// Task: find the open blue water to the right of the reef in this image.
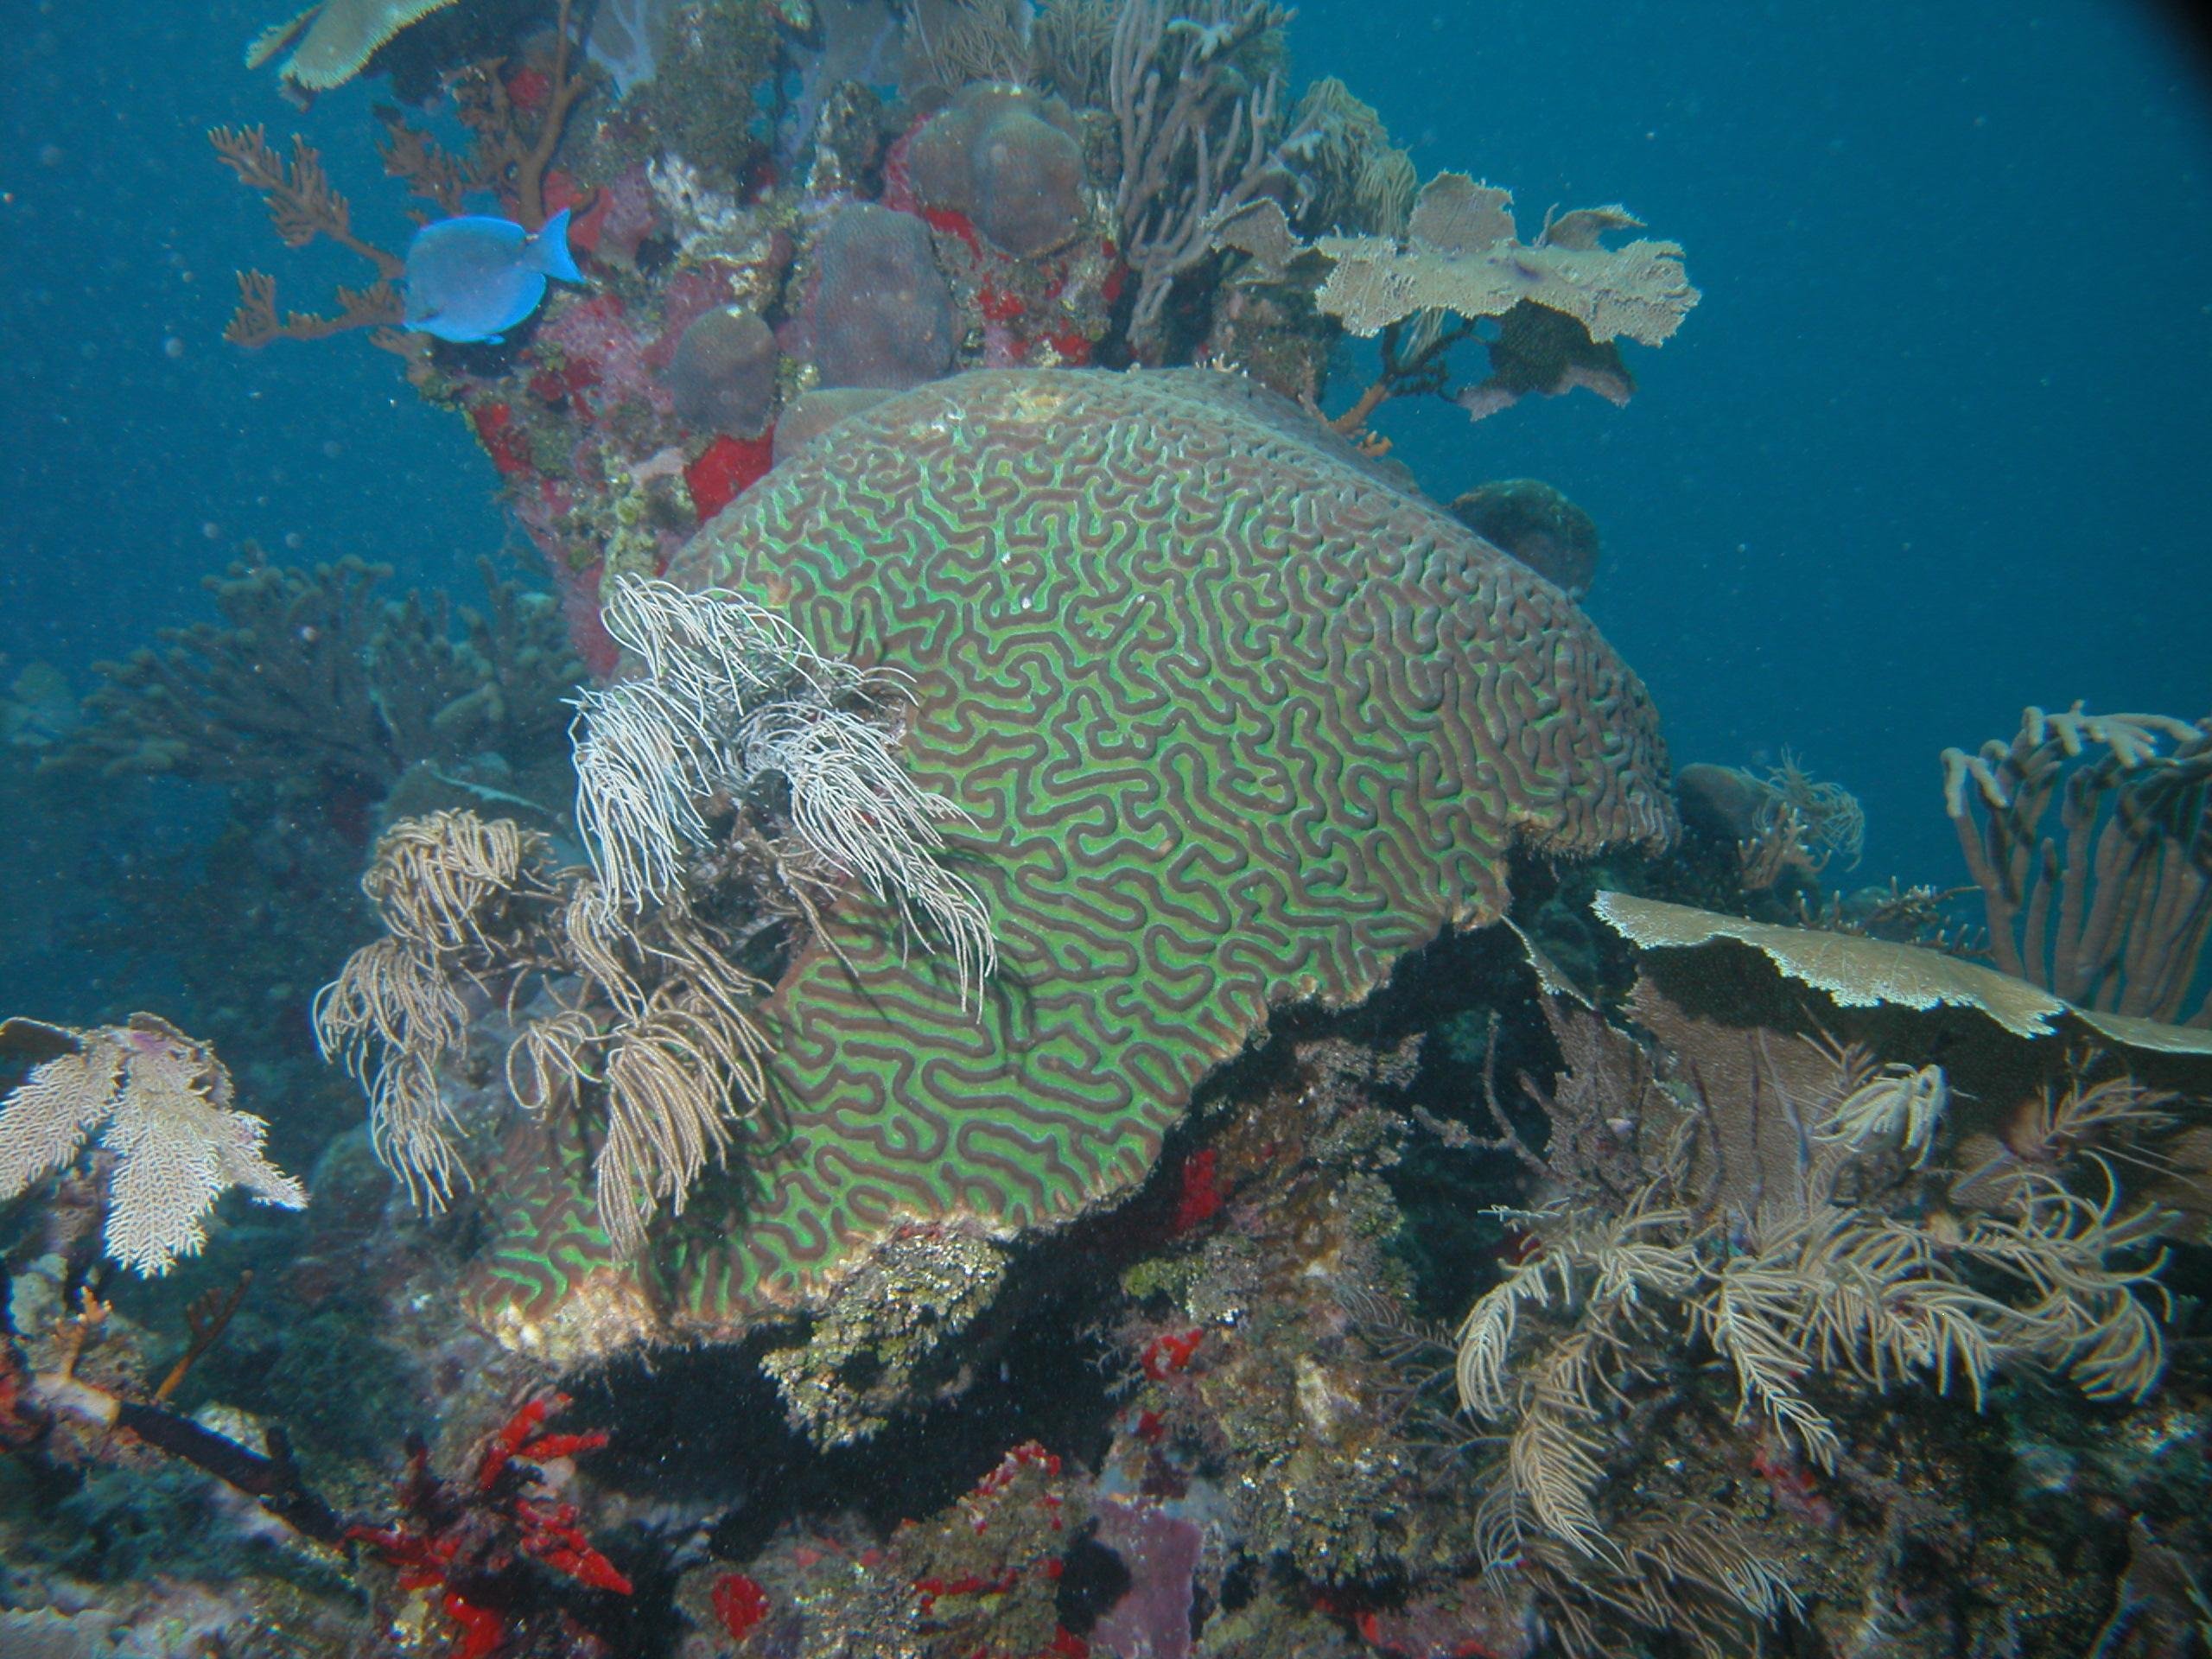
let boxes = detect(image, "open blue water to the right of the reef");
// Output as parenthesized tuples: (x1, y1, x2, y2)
(1299, 0, 2212, 882)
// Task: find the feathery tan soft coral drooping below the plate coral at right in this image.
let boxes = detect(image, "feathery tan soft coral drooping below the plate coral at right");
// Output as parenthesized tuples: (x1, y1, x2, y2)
(1458, 982, 2170, 1617)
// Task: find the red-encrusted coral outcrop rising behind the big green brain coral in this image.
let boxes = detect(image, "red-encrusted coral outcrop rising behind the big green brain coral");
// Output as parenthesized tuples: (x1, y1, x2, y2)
(217, 0, 1690, 675)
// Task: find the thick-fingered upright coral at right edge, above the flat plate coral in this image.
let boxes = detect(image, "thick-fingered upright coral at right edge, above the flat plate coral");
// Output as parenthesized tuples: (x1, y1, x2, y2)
(1942, 703, 2212, 1024)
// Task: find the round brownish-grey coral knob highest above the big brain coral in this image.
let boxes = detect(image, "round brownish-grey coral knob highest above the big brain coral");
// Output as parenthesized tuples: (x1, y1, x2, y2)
(907, 84, 1084, 259)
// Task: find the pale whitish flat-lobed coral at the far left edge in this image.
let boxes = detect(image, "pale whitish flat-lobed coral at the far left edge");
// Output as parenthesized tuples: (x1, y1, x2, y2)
(0, 1013, 308, 1274)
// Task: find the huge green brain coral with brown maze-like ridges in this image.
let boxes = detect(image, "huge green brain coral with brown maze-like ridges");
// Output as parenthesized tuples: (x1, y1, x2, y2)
(471, 370, 1672, 1336)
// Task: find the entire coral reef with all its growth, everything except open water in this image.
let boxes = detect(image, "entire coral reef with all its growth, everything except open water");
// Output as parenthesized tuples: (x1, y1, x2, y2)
(0, 0, 2212, 1659)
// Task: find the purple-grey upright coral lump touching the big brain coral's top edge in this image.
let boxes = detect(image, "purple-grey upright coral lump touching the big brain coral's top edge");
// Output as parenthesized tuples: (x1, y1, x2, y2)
(814, 201, 953, 391)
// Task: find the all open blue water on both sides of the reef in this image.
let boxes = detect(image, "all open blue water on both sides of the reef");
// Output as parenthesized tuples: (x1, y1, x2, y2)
(0, 0, 2212, 902)
